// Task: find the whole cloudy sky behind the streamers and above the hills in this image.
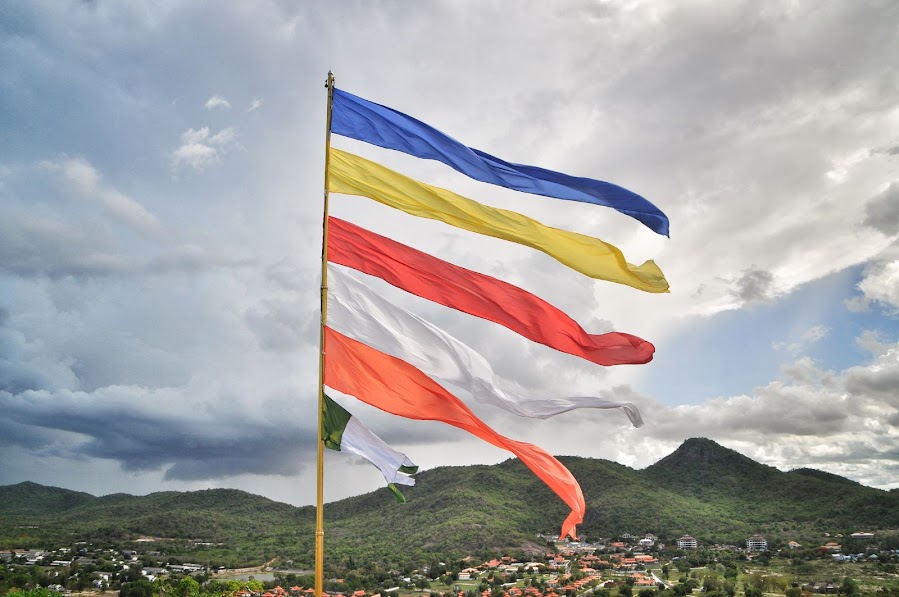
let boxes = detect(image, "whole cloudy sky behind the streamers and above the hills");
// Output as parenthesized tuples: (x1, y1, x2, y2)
(0, 0, 899, 505)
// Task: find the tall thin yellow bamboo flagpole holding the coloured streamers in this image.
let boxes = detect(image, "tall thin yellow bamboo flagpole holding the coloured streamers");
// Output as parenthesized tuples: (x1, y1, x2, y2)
(315, 71, 334, 597)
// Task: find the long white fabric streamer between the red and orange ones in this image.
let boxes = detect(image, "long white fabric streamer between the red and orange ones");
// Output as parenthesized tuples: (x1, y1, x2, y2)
(327, 265, 643, 427)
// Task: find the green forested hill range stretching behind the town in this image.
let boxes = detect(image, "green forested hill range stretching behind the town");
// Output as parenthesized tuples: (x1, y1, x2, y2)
(0, 439, 899, 563)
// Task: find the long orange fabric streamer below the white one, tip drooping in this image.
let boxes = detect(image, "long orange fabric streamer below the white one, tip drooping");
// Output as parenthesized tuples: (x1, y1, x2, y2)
(324, 326, 586, 537)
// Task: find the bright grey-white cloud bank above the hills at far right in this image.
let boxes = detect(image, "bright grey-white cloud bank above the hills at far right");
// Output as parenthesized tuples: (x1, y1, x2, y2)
(632, 344, 899, 486)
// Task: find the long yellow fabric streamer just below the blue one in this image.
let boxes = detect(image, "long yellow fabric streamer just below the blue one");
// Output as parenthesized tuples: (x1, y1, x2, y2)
(328, 147, 668, 292)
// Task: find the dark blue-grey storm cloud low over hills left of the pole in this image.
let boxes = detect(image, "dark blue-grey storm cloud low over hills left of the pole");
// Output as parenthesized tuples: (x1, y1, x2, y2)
(0, 387, 316, 480)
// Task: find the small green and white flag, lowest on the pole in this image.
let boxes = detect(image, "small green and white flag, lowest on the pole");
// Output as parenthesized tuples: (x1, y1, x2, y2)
(322, 394, 418, 502)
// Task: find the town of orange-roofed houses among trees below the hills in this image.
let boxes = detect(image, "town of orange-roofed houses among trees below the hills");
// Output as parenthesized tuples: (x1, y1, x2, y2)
(0, 531, 899, 597)
